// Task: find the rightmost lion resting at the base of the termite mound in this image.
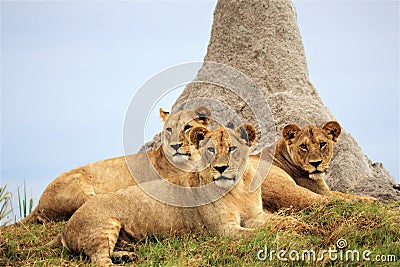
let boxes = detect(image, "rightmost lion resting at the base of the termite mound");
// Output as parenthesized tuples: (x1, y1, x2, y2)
(262, 121, 375, 211)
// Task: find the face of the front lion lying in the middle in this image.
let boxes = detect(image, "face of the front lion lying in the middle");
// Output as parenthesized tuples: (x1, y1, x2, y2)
(190, 124, 256, 188)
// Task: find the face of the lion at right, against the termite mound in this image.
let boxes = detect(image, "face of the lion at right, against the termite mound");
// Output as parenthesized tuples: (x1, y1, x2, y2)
(282, 121, 341, 179)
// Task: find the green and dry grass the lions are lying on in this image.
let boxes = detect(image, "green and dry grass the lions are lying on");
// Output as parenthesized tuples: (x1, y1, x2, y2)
(0, 201, 400, 267)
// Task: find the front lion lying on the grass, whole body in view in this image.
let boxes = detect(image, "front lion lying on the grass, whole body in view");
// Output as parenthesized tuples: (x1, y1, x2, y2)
(51, 124, 298, 266)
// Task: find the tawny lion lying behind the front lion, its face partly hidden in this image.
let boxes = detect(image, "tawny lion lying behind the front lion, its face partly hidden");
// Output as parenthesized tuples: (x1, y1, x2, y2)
(20, 107, 211, 223)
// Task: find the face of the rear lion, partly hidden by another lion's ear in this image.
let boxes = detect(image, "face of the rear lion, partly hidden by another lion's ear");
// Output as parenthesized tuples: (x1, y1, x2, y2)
(160, 107, 211, 164)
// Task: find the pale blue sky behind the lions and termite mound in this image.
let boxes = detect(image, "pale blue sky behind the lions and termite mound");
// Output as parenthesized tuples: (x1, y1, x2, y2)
(0, 1, 399, 215)
